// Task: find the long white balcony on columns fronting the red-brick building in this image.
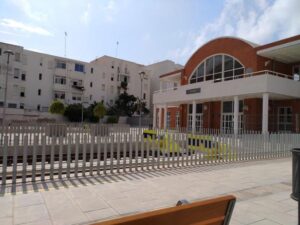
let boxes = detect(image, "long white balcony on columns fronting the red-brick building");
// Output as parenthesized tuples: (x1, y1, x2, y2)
(153, 70, 300, 104)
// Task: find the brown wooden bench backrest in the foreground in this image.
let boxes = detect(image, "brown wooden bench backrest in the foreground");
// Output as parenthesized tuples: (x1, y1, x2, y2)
(94, 195, 236, 225)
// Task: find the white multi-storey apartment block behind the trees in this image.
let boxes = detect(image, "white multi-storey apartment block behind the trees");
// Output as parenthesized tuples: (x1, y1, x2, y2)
(0, 42, 178, 123)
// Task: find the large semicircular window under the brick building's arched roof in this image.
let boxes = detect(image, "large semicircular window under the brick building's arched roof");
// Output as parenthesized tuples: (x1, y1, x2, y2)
(190, 54, 245, 84)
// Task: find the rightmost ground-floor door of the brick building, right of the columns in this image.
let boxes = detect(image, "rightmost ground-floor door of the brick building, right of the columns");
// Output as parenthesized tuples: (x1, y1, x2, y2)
(278, 107, 292, 132)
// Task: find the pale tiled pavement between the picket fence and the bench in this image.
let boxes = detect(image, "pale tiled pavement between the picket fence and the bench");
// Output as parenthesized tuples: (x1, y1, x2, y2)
(0, 159, 297, 225)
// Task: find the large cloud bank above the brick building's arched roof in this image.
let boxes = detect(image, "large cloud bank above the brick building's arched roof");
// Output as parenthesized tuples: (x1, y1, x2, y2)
(169, 0, 300, 62)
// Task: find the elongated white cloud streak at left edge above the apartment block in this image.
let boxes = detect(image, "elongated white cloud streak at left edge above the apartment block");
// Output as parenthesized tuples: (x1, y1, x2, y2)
(0, 18, 52, 36)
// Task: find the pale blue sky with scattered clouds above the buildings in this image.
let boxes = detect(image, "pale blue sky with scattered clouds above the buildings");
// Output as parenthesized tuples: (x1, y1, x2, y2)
(0, 0, 300, 65)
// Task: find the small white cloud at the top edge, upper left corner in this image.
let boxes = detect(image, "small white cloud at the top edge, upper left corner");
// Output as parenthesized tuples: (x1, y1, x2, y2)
(10, 0, 47, 21)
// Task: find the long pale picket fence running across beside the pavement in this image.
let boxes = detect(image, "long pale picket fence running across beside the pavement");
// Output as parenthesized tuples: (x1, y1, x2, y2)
(0, 125, 300, 185)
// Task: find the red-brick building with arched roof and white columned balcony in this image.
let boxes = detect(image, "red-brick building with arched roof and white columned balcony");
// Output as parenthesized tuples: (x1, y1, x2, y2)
(153, 35, 300, 133)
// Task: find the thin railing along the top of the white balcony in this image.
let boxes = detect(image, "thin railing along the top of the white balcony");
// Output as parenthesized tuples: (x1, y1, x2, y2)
(154, 70, 294, 94)
